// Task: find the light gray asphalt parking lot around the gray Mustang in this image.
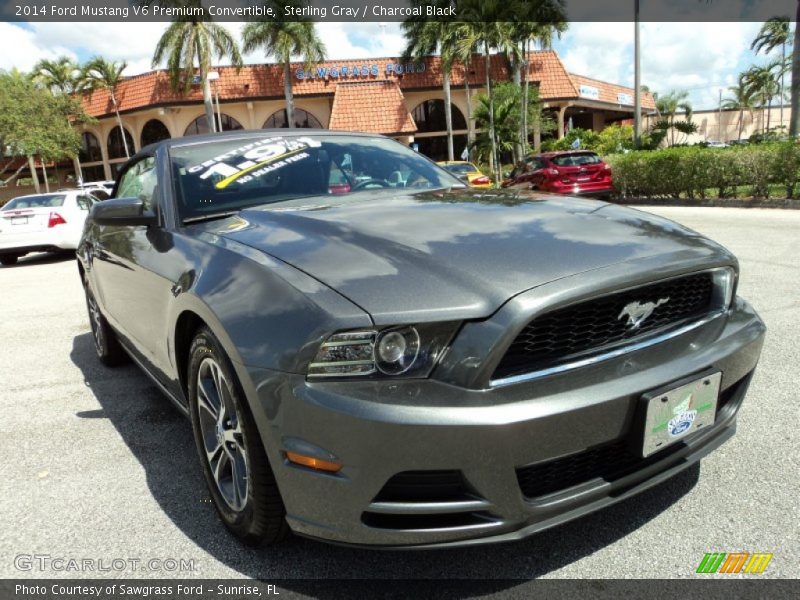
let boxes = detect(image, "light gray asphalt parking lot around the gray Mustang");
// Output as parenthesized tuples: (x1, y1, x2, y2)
(0, 208, 800, 580)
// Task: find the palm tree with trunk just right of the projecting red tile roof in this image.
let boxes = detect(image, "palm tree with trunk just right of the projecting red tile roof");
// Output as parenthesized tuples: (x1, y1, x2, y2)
(401, 0, 460, 160)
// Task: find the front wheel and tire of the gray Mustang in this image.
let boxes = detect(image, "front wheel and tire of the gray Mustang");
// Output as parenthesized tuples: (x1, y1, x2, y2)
(187, 327, 288, 546)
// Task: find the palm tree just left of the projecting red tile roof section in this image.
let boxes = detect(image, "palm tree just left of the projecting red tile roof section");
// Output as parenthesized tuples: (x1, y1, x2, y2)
(242, 0, 325, 127)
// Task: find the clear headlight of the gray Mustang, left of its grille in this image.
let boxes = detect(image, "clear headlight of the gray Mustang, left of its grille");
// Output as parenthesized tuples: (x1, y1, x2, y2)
(308, 323, 459, 379)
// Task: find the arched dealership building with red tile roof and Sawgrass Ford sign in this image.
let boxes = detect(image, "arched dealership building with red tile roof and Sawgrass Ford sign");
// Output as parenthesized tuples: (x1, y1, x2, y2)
(7, 51, 655, 189)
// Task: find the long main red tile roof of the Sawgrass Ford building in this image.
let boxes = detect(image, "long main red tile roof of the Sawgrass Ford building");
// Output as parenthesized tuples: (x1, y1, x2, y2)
(78, 51, 649, 117)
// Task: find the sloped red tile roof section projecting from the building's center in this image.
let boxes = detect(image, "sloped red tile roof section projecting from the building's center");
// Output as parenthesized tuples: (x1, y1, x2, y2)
(329, 80, 417, 134)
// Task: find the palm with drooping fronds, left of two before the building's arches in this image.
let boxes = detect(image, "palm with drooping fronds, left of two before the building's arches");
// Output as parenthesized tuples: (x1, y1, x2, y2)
(146, 0, 242, 132)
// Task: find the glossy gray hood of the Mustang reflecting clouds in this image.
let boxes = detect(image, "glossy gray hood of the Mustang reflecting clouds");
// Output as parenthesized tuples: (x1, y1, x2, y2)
(205, 190, 720, 324)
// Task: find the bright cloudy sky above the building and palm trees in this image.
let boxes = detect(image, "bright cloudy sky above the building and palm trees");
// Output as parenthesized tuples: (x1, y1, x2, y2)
(0, 22, 784, 110)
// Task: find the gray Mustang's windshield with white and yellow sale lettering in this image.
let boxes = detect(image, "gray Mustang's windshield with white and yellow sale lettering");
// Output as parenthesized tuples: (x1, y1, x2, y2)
(170, 133, 463, 220)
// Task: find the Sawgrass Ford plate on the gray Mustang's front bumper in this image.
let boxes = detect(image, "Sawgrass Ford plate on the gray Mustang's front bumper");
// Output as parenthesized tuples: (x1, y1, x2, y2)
(642, 371, 722, 456)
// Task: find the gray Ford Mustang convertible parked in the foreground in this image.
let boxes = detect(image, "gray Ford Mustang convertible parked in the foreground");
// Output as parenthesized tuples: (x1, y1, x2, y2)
(78, 130, 765, 547)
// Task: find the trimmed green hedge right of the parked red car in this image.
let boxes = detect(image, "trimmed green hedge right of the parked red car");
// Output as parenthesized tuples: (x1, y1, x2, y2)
(606, 141, 800, 198)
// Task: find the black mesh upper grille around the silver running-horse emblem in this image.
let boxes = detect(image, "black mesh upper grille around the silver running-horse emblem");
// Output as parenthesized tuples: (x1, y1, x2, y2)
(492, 272, 714, 379)
